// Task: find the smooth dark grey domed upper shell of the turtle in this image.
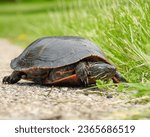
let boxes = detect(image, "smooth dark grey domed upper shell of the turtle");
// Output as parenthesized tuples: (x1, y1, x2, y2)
(11, 36, 109, 71)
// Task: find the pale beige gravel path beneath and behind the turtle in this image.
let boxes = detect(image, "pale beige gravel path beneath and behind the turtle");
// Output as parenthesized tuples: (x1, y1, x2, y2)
(0, 39, 150, 119)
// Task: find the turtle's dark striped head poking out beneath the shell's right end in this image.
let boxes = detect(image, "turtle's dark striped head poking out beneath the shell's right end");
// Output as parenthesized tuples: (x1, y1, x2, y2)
(89, 62, 116, 80)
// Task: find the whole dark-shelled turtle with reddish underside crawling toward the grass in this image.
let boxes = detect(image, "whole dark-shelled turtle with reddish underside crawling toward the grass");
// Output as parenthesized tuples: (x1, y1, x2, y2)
(2, 36, 127, 86)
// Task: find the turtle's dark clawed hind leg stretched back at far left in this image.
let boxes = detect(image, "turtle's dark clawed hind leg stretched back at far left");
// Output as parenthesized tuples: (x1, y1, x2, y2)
(2, 71, 25, 84)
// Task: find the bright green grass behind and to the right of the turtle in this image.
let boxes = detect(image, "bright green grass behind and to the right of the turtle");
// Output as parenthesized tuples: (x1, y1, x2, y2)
(0, 0, 150, 96)
